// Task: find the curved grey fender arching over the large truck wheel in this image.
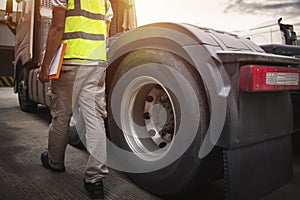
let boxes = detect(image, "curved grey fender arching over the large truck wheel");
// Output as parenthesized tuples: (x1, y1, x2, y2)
(107, 23, 230, 158)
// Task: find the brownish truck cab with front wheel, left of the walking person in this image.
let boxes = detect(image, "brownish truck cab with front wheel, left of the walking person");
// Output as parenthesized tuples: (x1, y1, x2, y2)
(7, 0, 52, 112)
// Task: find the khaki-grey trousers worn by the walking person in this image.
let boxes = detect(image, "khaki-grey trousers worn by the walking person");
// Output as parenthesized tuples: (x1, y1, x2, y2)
(48, 63, 109, 183)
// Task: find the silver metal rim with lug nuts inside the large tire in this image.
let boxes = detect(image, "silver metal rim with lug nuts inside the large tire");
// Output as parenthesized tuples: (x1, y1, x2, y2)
(121, 76, 176, 161)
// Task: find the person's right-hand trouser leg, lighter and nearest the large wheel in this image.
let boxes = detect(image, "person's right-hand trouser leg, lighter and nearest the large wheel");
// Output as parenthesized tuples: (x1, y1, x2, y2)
(73, 66, 109, 183)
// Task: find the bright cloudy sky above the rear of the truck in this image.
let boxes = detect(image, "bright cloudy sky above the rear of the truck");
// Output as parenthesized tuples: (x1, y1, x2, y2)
(0, 0, 300, 34)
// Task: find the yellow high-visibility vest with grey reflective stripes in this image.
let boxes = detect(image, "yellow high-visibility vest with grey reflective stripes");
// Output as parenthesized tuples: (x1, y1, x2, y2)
(63, 0, 106, 61)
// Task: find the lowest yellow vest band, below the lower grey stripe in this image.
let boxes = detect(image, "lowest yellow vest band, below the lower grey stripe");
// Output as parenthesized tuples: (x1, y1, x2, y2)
(63, 39, 106, 60)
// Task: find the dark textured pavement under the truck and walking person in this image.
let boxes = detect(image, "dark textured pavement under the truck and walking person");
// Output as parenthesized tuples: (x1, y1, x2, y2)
(0, 88, 300, 200)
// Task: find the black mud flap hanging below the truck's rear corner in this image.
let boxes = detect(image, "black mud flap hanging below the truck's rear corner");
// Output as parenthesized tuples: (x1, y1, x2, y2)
(223, 135, 293, 200)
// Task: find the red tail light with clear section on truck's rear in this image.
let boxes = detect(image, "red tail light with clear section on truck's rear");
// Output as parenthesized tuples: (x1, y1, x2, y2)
(240, 65, 300, 92)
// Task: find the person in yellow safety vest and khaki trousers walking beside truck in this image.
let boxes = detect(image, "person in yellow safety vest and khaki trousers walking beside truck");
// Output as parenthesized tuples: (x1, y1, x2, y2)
(39, 0, 113, 199)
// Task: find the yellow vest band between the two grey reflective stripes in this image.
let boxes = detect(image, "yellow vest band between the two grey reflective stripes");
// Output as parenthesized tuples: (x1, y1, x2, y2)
(65, 16, 106, 34)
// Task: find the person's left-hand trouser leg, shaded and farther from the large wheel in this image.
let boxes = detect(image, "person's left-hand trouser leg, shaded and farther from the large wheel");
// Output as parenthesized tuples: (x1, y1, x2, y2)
(48, 68, 76, 169)
